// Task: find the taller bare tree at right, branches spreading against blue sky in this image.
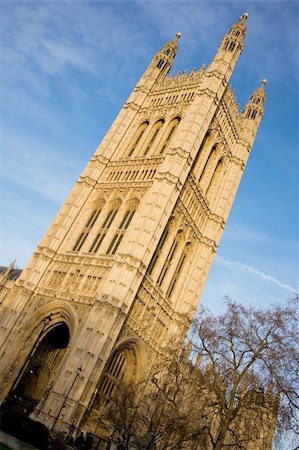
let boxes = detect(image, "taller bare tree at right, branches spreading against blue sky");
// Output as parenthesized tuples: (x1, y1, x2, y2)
(192, 297, 299, 450)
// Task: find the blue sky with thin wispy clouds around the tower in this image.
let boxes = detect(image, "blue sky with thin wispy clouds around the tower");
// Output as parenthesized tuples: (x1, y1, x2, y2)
(0, 0, 299, 311)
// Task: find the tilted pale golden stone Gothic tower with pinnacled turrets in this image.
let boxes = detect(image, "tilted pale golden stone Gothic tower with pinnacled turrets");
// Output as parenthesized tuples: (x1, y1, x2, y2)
(0, 14, 265, 436)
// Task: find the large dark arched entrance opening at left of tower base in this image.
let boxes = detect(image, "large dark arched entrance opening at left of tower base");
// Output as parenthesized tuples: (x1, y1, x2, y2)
(5, 322, 70, 414)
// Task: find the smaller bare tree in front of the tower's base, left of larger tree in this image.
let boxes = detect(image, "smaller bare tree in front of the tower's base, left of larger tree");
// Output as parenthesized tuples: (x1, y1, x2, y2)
(102, 351, 205, 450)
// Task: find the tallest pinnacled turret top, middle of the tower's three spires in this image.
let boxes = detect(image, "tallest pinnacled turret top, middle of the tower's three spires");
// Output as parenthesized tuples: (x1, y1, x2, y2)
(208, 13, 248, 82)
